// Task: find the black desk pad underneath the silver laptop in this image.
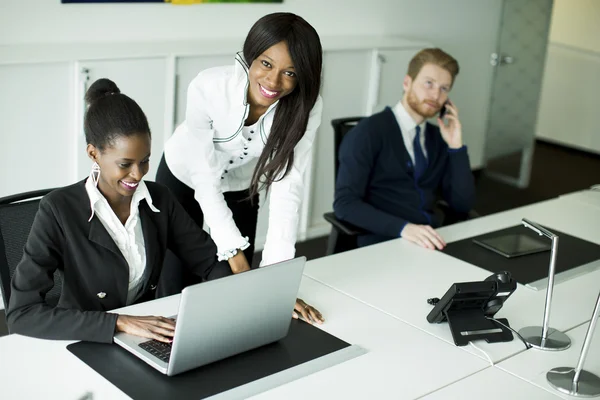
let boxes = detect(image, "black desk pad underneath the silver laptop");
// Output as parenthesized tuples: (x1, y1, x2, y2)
(67, 320, 350, 400)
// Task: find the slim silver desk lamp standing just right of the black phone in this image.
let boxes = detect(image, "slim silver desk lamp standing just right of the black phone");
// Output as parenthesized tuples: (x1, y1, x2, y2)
(519, 218, 571, 351)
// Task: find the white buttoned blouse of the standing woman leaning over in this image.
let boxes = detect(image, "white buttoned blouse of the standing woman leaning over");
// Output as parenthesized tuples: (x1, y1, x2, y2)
(165, 53, 323, 265)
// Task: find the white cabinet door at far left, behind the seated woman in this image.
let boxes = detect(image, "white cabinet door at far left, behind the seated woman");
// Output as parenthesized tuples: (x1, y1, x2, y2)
(0, 62, 75, 197)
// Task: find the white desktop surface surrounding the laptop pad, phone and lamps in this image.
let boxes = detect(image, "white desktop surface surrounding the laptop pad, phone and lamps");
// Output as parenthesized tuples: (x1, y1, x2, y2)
(0, 198, 600, 400)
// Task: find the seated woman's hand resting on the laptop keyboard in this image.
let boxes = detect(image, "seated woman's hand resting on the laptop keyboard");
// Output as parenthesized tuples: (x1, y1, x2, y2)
(116, 315, 175, 343)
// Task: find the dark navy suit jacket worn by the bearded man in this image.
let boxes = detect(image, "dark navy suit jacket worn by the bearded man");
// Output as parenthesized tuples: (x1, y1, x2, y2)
(333, 107, 475, 245)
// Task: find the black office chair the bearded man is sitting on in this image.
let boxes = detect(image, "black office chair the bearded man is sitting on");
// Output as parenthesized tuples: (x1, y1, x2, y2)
(323, 117, 479, 255)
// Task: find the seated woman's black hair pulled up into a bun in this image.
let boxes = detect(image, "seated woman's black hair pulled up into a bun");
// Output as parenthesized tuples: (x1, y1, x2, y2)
(83, 78, 150, 151)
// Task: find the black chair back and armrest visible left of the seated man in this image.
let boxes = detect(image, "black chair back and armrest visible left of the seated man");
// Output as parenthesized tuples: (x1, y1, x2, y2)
(323, 117, 365, 255)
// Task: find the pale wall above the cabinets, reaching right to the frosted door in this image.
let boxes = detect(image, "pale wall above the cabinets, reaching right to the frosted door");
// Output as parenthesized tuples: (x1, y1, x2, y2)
(0, 0, 502, 167)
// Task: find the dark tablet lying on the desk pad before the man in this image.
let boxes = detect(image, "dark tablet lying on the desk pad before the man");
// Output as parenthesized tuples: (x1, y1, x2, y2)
(473, 233, 550, 258)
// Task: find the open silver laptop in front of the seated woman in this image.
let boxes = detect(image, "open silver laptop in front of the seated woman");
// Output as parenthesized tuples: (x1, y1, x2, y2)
(114, 257, 306, 376)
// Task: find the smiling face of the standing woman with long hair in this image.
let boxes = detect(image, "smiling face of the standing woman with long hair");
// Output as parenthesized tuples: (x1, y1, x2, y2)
(248, 42, 298, 108)
